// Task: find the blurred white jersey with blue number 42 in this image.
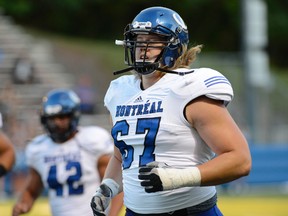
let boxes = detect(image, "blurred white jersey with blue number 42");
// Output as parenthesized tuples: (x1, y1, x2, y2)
(26, 126, 114, 216)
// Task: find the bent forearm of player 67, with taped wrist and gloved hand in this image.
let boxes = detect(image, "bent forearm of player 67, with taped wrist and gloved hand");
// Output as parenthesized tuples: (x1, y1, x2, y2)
(138, 148, 251, 193)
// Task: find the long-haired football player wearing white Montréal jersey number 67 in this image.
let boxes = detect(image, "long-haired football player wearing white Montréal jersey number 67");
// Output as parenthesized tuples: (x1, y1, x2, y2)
(91, 7, 251, 216)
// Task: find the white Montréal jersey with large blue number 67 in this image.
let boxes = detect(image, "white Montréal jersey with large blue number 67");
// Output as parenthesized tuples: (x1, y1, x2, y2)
(104, 68, 233, 214)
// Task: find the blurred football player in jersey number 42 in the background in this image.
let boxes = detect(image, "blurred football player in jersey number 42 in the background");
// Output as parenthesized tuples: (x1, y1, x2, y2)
(13, 89, 122, 216)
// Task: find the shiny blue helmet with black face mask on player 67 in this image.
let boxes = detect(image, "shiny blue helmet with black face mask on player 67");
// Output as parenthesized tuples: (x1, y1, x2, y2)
(117, 7, 189, 75)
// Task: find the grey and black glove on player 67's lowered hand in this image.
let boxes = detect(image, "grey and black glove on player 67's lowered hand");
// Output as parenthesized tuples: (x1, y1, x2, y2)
(90, 184, 112, 216)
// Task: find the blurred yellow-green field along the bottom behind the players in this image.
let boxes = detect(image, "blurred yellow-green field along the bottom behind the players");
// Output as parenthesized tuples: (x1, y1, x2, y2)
(0, 195, 288, 216)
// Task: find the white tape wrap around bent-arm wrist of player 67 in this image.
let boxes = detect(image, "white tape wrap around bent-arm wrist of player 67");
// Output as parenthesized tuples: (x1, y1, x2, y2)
(157, 167, 201, 190)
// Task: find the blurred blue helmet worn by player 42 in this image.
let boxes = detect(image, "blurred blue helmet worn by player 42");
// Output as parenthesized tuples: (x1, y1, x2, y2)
(40, 89, 80, 143)
